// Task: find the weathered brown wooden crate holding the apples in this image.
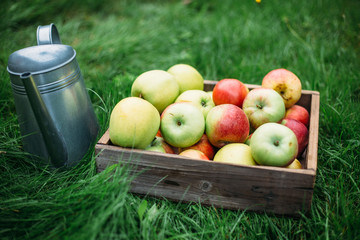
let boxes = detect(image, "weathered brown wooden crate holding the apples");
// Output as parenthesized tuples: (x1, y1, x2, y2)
(95, 81, 320, 216)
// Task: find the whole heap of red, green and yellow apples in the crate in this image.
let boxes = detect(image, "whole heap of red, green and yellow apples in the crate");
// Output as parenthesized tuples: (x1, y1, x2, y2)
(109, 64, 309, 168)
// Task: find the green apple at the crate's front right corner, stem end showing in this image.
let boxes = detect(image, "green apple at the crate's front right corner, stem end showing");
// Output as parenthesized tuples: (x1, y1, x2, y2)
(250, 123, 298, 167)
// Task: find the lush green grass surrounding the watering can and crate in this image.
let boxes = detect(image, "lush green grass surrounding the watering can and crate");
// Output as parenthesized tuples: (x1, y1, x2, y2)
(0, 0, 360, 239)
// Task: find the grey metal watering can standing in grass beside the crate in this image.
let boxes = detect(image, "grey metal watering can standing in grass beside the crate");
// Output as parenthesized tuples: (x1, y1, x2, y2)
(7, 24, 99, 167)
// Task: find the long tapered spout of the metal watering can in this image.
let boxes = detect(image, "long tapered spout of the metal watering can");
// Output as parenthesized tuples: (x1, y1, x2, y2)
(20, 72, 68, 167)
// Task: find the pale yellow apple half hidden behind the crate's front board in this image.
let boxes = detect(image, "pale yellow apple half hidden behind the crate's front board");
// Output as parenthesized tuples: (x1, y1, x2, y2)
(214, 143, 257, 166)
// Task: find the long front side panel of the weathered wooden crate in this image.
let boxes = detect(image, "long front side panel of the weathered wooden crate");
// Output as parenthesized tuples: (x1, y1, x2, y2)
(97, 146, 314, 215)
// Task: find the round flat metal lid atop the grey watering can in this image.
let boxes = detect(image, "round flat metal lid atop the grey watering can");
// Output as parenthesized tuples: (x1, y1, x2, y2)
(7, 44, 76, 75)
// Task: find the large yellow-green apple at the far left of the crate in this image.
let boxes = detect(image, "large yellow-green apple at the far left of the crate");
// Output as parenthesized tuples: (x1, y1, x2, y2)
(109, 97, 160, 149)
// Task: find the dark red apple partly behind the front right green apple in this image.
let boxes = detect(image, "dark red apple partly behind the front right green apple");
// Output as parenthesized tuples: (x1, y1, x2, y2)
(281, 118, 309, 157)
